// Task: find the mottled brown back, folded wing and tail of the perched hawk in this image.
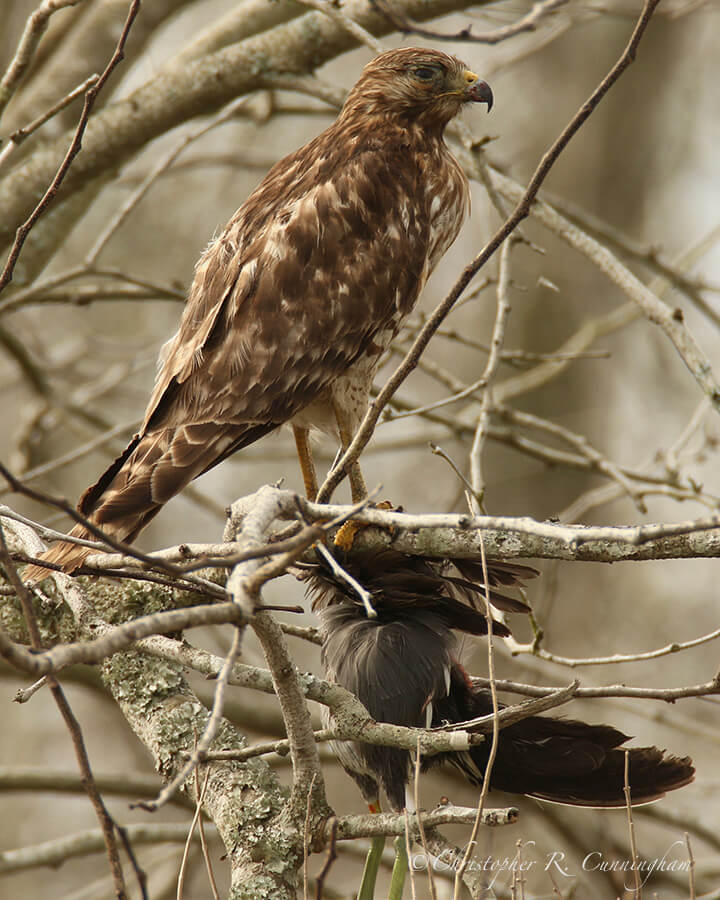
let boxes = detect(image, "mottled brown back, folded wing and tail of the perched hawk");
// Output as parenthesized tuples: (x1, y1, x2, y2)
(28, 129, 448, 576)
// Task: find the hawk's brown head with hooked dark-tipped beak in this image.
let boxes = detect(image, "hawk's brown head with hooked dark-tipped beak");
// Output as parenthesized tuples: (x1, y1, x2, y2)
(345, 47, 493, 129)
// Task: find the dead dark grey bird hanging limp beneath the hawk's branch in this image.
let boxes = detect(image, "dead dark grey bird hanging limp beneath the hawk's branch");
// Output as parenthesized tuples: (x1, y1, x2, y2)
(306, 550, 694, 896)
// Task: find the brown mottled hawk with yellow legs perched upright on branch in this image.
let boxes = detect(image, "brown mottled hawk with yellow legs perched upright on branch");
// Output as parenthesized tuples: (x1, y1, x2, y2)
(27, 48, 493, 579)
